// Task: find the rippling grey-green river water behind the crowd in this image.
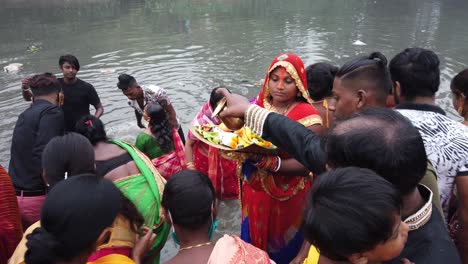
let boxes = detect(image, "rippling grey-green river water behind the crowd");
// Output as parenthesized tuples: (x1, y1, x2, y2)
(0, 0, 468, 259)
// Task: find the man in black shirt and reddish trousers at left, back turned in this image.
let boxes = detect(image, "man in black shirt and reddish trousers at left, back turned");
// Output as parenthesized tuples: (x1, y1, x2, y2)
(8, 73, 64, 229)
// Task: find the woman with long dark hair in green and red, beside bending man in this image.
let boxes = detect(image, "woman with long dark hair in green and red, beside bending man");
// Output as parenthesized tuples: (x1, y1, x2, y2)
(135, 102, 186, 179)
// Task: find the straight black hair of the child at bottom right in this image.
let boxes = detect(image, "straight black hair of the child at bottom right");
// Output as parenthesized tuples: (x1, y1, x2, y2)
(303, 167, 401, 261)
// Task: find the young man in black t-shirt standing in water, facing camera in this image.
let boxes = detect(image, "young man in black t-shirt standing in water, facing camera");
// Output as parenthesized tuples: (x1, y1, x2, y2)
(58, 54, 104, 131)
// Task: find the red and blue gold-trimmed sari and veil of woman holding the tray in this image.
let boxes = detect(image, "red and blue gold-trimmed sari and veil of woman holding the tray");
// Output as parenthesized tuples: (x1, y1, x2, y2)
(241, 54, 322, 263)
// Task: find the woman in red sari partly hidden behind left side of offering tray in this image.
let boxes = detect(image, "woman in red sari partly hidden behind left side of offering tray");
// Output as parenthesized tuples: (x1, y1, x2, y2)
(185, 87, 239, 200)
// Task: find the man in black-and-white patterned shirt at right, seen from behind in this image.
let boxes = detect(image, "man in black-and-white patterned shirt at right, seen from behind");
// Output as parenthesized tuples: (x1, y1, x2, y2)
(389, 48, 468, 262)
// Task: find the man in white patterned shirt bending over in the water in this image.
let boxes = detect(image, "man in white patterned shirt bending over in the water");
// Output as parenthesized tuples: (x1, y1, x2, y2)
(117, 73, 185, 144)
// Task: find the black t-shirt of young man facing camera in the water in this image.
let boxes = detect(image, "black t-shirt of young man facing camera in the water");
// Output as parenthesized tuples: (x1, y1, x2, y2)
(58, 78, 101, 131)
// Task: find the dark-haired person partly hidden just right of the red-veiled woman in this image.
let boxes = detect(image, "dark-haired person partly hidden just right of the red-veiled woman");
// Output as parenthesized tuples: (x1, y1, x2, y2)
(306, 63, 338, 130)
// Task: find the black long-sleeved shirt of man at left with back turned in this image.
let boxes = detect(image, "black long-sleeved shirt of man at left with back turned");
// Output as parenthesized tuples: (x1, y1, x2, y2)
(8, 100, 64, 191)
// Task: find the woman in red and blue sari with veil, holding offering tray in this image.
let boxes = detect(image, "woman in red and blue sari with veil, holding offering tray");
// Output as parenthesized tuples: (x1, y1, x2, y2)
(241, 53, 322, 263)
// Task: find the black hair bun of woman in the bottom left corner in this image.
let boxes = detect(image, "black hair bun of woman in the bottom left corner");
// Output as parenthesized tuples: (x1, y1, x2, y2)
(24, 227, 60, 264)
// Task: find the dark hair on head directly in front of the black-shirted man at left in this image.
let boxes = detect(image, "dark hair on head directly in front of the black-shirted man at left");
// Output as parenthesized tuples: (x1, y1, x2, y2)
(42, 132, 95, 188)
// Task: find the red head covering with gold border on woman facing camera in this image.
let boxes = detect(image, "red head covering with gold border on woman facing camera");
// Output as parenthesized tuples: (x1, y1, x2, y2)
(257, 53, 312, 108)
